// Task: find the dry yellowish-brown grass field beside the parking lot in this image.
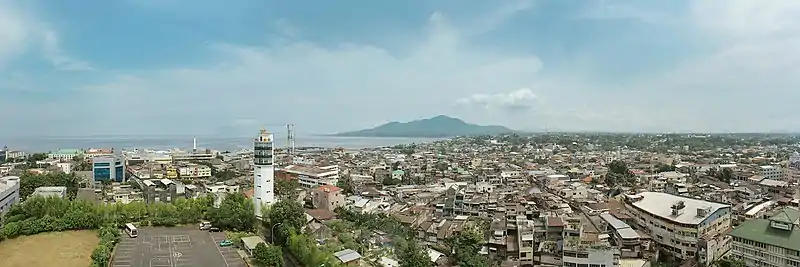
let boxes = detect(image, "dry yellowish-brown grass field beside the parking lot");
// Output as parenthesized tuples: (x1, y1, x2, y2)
(0, 231, 100, 267)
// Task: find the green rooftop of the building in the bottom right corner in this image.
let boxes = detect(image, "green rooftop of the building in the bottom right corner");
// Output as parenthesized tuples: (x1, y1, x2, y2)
(729, 208, 800, 251)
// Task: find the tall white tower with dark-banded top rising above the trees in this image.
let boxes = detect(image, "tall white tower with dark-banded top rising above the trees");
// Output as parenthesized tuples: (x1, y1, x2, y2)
(253, 129, 275, 219)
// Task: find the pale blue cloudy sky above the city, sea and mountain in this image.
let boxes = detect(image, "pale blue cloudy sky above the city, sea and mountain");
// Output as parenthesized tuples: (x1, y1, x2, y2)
(0, 0, 800, 136)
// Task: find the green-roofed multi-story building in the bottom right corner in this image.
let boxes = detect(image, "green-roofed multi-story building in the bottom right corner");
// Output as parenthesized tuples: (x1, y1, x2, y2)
(729, 208, 800, 267)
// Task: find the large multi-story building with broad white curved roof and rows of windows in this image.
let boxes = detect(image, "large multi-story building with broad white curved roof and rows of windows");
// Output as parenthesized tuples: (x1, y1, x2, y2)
(625, 192, 731, 266)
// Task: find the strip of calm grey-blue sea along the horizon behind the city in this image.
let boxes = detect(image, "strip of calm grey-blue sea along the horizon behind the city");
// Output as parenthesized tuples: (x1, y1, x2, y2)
(0, 135, 440, 152)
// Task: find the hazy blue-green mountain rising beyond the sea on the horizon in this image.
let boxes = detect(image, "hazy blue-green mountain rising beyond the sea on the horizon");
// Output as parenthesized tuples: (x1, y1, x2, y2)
(333, 115, 515, 138)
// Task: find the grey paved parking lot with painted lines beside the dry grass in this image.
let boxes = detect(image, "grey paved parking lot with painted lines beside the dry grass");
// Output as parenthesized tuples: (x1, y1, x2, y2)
(112, 227, 246, 267)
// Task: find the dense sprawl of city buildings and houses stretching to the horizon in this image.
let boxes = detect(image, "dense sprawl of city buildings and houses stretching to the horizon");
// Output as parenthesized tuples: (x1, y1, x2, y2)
(0, 131, 800, 267)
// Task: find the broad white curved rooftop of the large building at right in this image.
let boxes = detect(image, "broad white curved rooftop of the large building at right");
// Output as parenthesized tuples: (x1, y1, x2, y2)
(628, 192, 730, 224)
